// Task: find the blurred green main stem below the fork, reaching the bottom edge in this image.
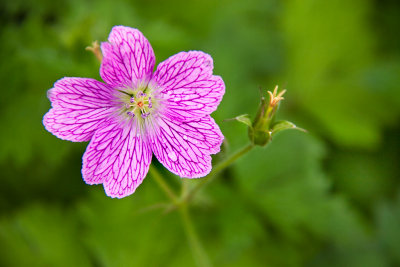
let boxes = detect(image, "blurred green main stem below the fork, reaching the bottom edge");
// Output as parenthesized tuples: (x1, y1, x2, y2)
(179, 203, 211, 267)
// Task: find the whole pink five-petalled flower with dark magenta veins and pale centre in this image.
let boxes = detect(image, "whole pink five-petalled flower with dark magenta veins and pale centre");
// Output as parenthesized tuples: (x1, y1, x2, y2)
(43, 26, 225, 198)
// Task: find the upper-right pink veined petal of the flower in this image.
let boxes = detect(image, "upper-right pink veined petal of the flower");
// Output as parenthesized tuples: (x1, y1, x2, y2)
(153, 51, 225, 121)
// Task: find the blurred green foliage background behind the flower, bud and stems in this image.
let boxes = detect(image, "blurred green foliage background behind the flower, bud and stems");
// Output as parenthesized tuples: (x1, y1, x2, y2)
(0, 0, 400, 266)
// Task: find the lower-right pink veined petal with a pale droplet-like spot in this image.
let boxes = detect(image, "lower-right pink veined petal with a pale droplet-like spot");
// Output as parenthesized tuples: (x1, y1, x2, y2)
(149, 115, 224, 178)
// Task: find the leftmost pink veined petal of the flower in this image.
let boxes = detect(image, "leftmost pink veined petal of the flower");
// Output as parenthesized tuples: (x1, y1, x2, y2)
(43, 78, 113, 142)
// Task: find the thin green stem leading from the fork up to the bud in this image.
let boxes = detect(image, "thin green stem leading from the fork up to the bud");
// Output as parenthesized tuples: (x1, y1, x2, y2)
(184, 144, 254, 202)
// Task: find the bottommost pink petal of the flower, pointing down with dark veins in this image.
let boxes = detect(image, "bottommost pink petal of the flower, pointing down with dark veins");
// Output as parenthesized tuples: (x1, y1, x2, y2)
(82, 121, 152, 198)
